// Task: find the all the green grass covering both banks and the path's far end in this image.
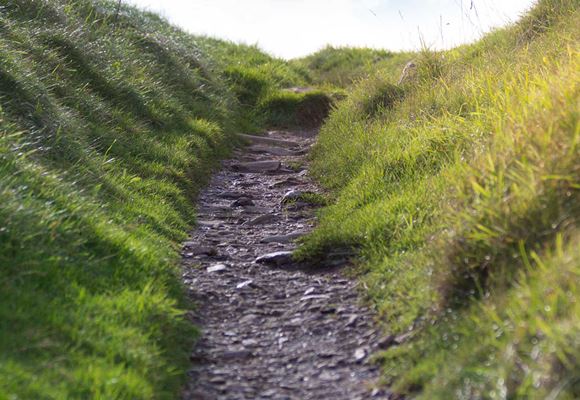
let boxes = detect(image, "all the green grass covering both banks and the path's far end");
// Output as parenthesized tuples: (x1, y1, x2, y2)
(0, 0, 580, 399)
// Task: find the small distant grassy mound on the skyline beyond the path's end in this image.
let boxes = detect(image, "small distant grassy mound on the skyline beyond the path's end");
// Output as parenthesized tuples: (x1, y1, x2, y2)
(291, 46, 412, 88)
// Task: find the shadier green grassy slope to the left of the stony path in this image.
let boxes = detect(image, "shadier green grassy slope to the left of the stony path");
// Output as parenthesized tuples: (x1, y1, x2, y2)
(0, 0, 303, 399)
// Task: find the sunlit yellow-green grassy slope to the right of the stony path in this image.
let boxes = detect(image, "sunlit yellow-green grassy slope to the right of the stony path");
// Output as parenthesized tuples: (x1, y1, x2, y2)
(301, 0, 580, 399)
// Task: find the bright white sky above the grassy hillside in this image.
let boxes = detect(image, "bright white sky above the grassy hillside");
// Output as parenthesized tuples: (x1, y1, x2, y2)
(125, 0, 534, 59)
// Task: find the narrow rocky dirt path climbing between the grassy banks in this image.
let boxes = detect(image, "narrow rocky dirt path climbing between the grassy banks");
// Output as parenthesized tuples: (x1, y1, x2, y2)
(183, 132, 388, 400)
